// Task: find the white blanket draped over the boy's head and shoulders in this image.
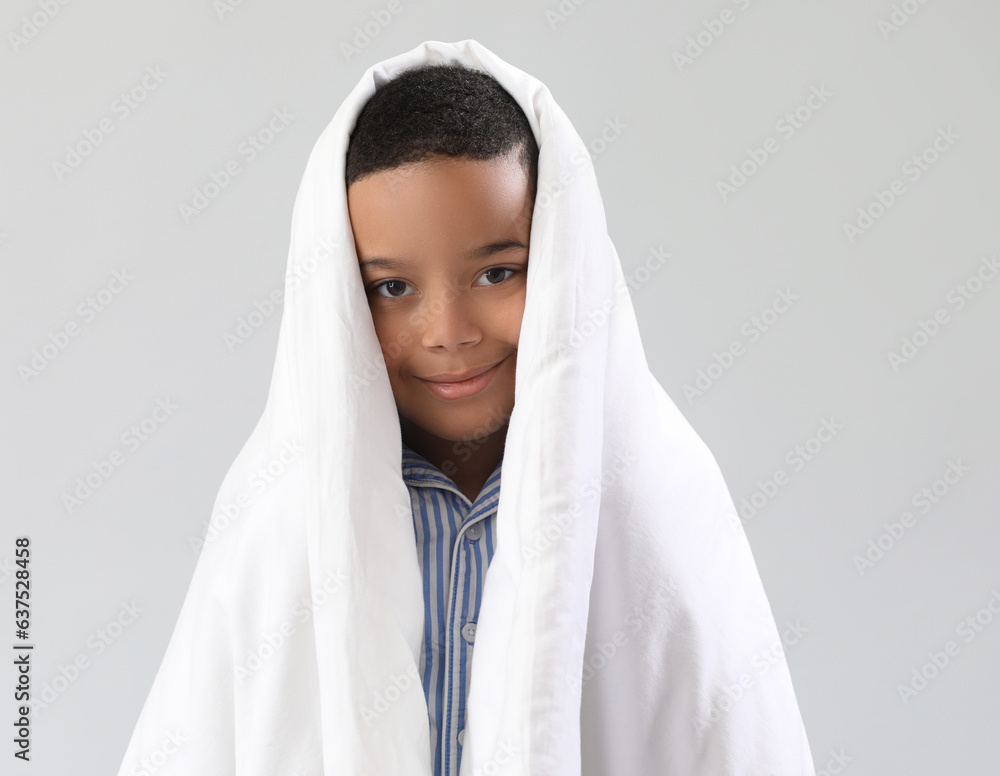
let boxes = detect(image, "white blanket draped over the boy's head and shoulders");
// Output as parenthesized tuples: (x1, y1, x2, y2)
(120, 40, 814, 776)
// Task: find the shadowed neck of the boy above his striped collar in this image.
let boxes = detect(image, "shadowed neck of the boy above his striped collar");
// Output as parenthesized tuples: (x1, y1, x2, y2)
(399, 415, 507, 501)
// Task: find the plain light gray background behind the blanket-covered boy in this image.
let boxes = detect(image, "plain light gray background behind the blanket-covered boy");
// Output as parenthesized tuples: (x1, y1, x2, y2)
(0, 0, 1000, 776)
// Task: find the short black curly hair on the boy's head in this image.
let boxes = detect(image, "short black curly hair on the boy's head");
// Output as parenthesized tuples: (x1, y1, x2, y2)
(345, 63, 538, 191)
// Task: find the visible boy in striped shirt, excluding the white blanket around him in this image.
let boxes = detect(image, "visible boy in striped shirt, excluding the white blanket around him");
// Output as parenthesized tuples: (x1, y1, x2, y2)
(346, 65, 538, 775)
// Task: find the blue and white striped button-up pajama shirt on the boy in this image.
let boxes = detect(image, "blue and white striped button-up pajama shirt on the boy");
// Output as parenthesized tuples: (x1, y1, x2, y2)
(402, 442, 503, 776)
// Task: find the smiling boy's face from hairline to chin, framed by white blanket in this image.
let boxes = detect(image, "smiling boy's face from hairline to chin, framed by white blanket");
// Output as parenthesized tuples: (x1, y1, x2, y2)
(347, 156, 534, 442)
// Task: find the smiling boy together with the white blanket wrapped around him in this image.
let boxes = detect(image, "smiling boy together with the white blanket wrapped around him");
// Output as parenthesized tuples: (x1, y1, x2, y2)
(120, 40, 814, 776)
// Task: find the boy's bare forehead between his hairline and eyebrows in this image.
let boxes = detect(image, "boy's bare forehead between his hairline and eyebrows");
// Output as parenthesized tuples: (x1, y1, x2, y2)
(347, 156, 532, 258)
